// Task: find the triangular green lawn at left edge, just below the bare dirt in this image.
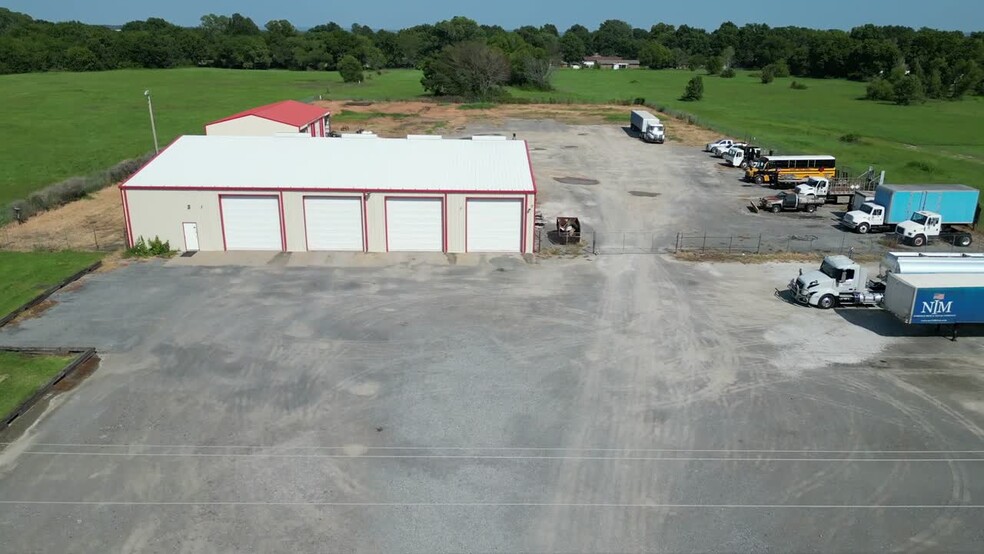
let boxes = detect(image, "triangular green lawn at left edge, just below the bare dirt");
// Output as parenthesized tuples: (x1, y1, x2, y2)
(0, 251, 103, 316)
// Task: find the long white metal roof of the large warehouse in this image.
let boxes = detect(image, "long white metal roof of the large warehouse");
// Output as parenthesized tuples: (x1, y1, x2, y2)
(123, 135, 535, 192)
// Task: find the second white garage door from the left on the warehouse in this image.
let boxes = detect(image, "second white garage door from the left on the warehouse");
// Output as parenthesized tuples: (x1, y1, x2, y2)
(304, 197, 364, 252)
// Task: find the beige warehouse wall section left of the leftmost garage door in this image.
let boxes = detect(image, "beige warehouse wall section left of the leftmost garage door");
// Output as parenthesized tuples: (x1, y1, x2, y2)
(125, 190, 225, 250)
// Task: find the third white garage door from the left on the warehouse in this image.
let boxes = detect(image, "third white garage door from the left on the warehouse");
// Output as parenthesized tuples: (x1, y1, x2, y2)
(386, 198, 444, 252)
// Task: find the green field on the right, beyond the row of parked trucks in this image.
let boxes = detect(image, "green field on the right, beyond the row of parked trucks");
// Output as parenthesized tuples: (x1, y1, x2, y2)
(512, 70, 984, 187)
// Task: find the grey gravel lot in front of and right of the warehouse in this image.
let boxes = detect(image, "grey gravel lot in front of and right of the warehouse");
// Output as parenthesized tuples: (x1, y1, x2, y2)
(0, 122, 984, 552)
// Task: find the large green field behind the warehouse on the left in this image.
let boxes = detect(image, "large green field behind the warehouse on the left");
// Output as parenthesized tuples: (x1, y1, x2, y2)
(0, 68, 423, 206)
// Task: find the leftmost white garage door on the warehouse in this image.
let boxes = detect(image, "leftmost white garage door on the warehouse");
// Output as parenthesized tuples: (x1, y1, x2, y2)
(220, 196, 283, 250)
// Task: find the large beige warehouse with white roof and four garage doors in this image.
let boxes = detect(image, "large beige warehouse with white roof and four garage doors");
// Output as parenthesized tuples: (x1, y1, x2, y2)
(120, 135, 536, 253)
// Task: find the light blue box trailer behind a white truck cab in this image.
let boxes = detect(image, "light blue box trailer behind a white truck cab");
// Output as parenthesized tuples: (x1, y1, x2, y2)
(875, 185, 980, 225)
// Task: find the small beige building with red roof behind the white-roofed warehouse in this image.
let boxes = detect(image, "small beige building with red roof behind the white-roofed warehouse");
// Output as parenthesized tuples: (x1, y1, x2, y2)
(205, 100, 331, 137)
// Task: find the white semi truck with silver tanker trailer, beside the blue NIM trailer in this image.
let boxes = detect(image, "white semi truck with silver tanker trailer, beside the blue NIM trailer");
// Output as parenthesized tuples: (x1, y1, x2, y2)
(788, 252, 984, 310)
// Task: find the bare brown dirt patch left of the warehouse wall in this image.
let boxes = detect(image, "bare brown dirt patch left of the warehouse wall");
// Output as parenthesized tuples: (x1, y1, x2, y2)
(0, 186, 125, 250)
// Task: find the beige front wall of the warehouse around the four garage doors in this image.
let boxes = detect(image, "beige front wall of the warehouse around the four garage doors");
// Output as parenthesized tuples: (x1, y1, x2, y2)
(126, 190, 535, 253)
